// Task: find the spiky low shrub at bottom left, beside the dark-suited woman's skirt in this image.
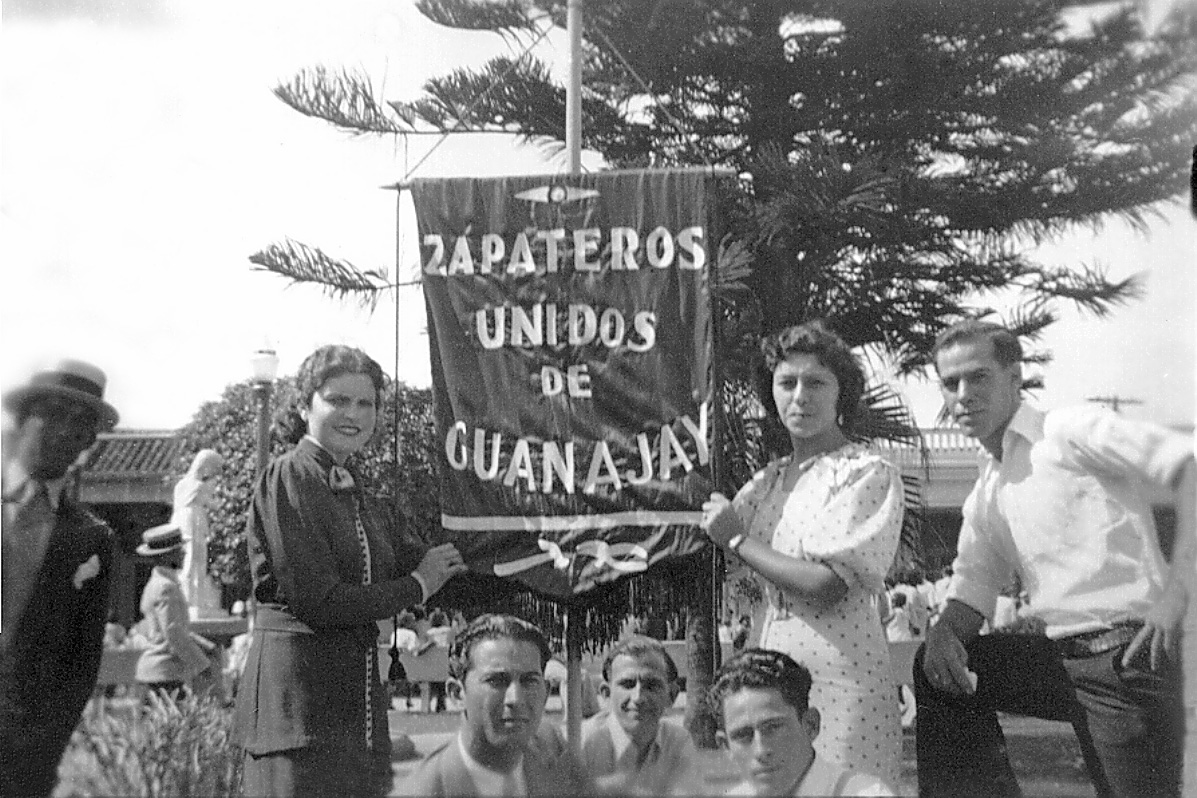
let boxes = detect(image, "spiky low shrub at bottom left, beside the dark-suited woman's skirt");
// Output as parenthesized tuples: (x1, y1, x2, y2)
(56, 694, 242, 798)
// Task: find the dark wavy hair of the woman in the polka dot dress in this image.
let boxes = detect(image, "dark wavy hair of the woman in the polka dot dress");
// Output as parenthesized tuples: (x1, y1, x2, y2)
(757, 321, 865, 432)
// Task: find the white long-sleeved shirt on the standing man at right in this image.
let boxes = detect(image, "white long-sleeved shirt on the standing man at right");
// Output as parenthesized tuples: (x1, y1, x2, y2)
(947, 403, 1192, 638)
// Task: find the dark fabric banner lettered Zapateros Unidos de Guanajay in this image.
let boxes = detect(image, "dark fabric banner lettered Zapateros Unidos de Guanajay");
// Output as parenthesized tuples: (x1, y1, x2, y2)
(411, 170, 719, 597)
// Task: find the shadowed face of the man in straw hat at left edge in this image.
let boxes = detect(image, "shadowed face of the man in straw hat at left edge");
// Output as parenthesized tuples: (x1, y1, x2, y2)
(5, 396, 99, 481)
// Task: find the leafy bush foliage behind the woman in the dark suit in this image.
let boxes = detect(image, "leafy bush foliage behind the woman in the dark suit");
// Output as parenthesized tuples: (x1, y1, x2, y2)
(174, 378, 440, 596)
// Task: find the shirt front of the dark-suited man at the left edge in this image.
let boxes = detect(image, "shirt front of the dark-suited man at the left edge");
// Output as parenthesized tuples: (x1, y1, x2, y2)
(0, 481, 54, 636)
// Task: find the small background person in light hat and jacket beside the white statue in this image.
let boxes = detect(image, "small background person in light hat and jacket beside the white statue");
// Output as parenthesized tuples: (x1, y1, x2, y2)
(136, 524, 212, 698)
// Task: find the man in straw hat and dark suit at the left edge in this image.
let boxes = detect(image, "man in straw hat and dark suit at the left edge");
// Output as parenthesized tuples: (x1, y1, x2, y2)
(0, 360, 120, 796)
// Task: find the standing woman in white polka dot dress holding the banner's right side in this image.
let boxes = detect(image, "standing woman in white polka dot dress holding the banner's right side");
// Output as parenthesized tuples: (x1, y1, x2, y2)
(703, 323, 904, 785)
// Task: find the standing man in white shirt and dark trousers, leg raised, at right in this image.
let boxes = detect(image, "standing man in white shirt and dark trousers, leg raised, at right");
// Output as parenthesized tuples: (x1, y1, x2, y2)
(915, 321, 1197, 796)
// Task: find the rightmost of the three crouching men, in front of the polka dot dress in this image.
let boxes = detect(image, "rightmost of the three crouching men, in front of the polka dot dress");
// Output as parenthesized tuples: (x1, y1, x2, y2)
(709, 648, 897, 796)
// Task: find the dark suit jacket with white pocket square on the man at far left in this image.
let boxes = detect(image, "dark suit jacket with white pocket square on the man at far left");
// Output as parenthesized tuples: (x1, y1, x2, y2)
(0, 497, 113, 794)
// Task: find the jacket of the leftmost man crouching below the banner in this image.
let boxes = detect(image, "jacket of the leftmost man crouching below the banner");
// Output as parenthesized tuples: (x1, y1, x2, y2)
(391, 725, 594, 796)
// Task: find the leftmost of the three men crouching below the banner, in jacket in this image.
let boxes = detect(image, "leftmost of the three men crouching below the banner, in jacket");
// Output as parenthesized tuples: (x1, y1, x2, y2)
(397, 614, 591, 796)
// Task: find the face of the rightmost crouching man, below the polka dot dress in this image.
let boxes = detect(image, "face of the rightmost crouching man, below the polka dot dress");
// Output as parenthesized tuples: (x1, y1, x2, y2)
(718, 688, 819, 796)
